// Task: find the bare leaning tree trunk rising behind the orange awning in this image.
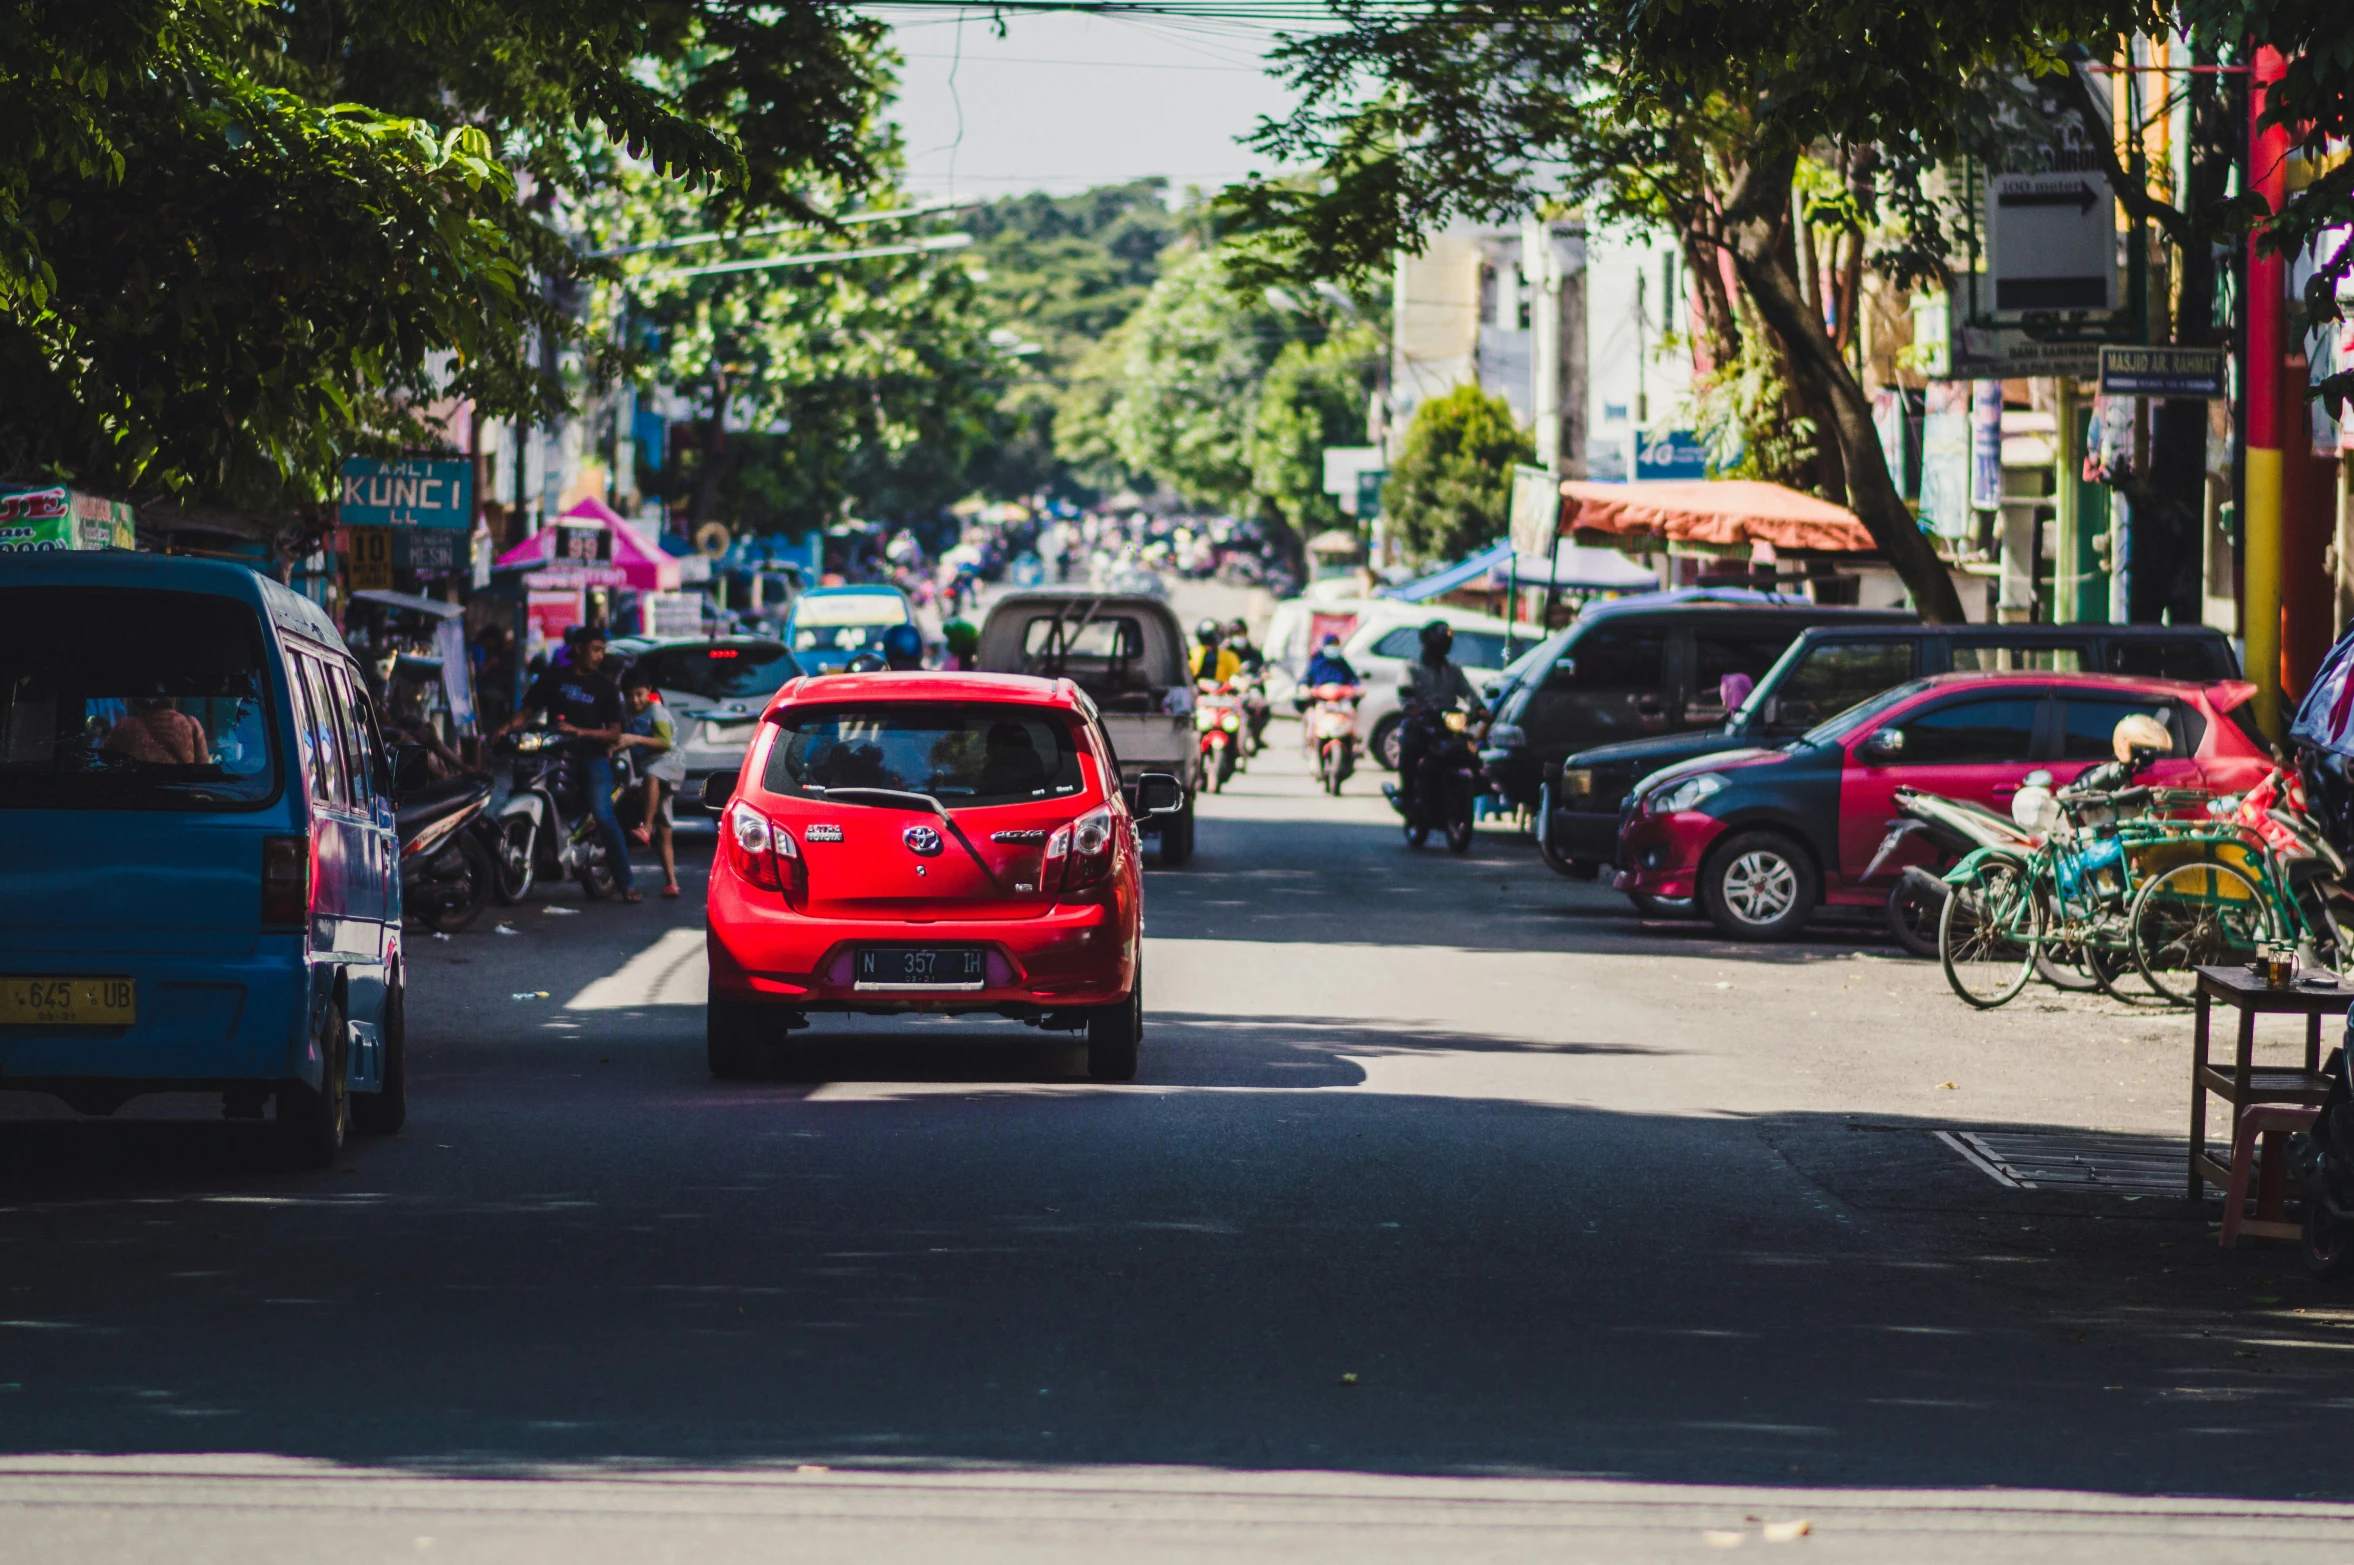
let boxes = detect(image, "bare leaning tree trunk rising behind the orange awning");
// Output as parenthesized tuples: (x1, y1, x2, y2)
(1725, 148, 1963, 624)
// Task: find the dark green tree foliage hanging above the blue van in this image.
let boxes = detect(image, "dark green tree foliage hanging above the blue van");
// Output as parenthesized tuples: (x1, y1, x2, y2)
(0, 0, 887, 508)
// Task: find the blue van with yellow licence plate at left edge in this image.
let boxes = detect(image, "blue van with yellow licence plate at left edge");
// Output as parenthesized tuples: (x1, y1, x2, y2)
(0, 553, 407, 1167)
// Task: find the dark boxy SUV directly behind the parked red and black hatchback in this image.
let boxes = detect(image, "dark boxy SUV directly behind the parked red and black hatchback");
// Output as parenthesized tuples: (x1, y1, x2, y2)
(1537, 621, 2239, 878)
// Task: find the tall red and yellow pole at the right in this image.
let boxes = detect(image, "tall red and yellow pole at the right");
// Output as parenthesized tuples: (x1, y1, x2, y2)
(2241, 47, 2288, 739)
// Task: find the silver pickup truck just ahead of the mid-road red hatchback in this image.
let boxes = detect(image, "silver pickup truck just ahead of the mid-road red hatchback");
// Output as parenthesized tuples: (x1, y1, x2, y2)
(975, 588, 1196, 866)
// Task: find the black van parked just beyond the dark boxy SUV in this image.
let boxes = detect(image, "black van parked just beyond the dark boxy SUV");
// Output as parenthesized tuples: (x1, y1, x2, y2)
(1481, 588, 1916, 812)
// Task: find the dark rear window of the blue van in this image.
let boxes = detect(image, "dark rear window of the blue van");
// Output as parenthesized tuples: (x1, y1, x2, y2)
(0, 588, 278, 810)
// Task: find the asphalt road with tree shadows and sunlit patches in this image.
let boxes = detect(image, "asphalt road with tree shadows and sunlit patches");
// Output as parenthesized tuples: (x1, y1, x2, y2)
(0, 727, 2354, 1563)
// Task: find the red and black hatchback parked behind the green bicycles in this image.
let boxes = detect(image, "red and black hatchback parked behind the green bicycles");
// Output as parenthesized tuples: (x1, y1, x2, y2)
(1615, 673, 2272, 939)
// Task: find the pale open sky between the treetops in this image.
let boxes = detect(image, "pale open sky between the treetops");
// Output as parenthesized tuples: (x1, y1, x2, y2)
(866, 5, 1290, 198)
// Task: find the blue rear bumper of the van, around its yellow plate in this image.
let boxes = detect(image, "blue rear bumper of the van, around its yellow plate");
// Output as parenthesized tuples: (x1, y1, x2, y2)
(0, 934, 315, 1092)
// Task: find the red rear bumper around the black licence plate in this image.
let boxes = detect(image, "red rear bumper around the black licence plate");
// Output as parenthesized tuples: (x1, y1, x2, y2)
(706, 875, 1137, 1014)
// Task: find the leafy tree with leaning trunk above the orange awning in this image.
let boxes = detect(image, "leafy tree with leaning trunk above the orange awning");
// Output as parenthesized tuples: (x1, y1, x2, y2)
(1226, 0, 2163, 619)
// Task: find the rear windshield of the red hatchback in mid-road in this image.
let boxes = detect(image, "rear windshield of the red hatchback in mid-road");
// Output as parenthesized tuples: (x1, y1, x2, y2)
(760, 701, 1085, 807)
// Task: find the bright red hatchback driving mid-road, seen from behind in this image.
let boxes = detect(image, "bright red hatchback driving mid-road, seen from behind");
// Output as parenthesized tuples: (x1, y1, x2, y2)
(704, 673, 1182, 1080)
